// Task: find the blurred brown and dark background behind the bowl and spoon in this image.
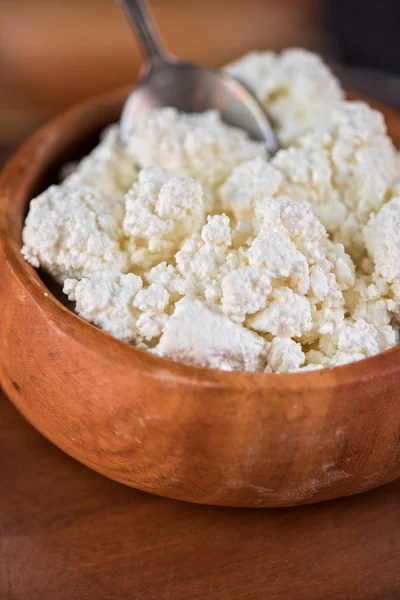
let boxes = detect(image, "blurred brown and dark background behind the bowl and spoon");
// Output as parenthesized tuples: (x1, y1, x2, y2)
(0, 0, 400, 162)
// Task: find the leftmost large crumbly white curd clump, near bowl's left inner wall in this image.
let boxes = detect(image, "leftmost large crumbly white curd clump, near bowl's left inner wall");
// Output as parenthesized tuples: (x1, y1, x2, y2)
(22, 185, 129, 282)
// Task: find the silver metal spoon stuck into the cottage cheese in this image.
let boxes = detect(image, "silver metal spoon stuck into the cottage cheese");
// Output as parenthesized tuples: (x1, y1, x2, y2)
(118, 0, 278, 154)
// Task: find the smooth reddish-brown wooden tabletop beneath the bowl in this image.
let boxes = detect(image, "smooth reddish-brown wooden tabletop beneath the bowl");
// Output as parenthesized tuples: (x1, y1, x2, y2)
(0, 392, 400, 600)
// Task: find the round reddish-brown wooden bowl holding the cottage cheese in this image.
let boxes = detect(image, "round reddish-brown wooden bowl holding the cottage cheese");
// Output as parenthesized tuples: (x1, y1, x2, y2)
(0, 90, 400, 507)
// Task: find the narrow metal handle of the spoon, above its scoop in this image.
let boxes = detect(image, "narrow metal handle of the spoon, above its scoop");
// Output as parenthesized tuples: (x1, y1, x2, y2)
(118, 0, 168, 63)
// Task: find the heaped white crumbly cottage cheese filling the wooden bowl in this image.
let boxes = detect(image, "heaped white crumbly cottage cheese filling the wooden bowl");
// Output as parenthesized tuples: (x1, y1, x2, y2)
(22, 49, 400, 372)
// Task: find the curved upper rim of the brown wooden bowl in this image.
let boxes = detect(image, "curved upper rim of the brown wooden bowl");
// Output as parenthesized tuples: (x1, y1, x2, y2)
(0, 86, 400, 391)
